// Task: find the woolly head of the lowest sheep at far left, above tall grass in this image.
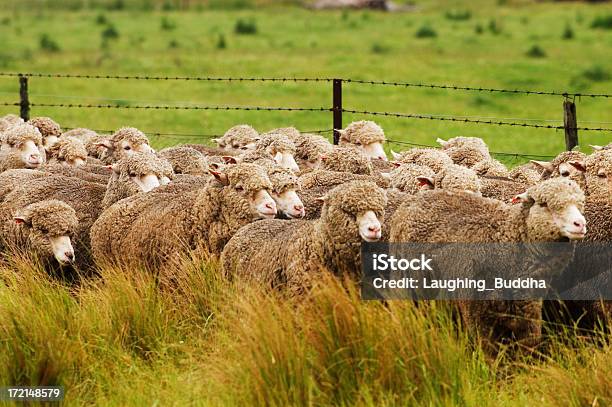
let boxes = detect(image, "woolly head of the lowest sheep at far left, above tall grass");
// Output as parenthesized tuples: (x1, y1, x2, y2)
(14, 201, 78, 265)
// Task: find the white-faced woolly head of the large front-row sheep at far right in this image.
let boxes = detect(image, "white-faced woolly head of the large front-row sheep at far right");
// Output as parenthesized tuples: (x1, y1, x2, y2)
(515, 178, 587, 241)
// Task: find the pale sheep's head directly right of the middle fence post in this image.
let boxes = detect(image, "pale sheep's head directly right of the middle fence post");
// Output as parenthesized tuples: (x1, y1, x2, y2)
(336, 120, 387, 161)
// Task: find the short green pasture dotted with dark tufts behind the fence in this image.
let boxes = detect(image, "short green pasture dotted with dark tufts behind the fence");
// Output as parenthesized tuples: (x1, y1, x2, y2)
(0, 0, 612, 163)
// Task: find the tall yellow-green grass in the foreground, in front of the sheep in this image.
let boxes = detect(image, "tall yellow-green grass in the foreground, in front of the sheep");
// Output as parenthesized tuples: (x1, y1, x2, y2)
(0, 253, 612, 406)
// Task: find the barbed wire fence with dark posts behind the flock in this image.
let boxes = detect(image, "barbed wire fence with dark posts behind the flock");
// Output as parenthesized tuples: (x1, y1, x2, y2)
(0, 72, 612, 159)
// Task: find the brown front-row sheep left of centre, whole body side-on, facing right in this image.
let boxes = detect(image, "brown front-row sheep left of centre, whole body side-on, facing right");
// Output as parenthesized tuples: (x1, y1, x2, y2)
(91, 163, 277, 268)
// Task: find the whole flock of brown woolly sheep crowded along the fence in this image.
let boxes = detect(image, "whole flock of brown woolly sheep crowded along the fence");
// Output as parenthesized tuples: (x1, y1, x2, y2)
(0, 115, 612, 350)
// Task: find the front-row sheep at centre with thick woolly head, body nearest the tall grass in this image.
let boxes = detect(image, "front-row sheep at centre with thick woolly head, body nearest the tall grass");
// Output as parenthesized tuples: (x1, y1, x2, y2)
(221, 181, 387, 294)
